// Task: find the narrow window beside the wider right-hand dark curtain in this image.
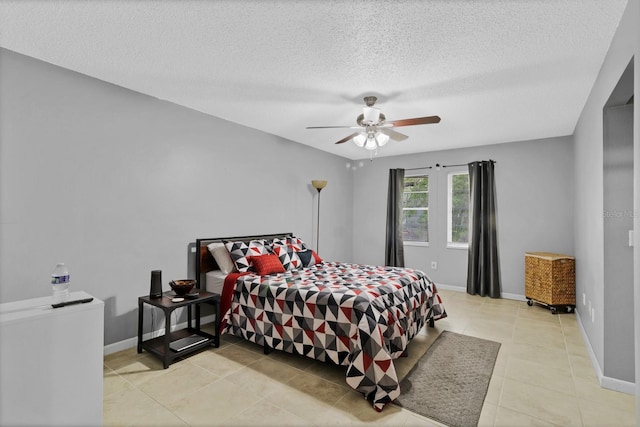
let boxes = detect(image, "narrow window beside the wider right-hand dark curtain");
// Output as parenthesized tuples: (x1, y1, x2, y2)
(447, 172, 469, 248)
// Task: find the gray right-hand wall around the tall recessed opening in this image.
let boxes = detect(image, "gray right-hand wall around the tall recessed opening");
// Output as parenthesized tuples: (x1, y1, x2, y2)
(574, 0, 640, 398)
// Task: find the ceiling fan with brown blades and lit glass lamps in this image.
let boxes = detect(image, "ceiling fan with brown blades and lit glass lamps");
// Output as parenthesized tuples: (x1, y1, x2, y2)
(307, 96, 440, 150)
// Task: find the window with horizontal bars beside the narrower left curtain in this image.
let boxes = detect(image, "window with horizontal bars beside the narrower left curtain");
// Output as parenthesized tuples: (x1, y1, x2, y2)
(402, 175, 429, 244)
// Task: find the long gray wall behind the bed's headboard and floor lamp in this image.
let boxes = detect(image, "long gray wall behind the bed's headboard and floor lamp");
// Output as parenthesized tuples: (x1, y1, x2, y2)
(0, 50, 353, 344)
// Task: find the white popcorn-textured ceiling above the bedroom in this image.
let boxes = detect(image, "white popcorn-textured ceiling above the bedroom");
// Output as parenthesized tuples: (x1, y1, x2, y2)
(0, 0, 627, 159)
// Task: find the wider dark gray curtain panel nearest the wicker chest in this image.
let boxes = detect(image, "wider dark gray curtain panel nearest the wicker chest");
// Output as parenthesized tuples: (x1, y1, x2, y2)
(467, 160, 501, 298)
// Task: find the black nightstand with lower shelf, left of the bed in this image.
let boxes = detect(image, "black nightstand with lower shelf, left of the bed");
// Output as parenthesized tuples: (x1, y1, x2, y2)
(138, 290, 220, 369)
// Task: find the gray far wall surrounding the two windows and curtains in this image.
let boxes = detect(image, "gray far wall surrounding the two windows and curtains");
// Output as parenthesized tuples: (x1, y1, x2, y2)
(353, 137, 574, 298)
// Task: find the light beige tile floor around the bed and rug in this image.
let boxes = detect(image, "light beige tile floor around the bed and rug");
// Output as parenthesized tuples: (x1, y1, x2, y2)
(103, 290, 636, 427)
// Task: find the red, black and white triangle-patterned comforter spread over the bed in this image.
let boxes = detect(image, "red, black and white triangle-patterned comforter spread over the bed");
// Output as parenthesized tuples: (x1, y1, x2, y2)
(222, 262, 447, 411)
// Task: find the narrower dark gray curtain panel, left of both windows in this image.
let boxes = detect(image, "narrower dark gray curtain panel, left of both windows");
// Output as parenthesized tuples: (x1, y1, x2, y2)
(384, 169, 404, 267)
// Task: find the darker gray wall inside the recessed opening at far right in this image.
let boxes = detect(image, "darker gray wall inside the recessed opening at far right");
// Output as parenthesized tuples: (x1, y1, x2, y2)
(603, 104, 635, 383)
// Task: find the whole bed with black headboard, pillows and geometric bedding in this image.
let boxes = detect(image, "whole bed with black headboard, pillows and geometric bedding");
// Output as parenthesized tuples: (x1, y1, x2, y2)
(196, 233, 447, 411)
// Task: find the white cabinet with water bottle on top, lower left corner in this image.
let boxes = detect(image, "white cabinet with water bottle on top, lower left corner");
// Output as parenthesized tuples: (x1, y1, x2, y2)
(0, 292, 104, 426)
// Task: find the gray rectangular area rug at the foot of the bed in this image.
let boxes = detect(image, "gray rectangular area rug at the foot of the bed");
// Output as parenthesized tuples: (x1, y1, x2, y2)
(395, 331, 500, 427)
